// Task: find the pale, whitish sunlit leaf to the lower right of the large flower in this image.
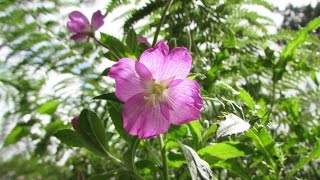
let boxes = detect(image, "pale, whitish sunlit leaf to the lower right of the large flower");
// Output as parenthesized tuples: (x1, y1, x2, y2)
(217, 113, 250, 138)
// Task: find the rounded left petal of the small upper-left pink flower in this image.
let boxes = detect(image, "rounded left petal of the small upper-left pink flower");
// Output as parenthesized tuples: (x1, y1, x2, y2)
(67, 11, 90, 33)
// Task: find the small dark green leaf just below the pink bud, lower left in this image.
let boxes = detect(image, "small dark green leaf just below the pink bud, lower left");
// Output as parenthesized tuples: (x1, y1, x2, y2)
(54, 129, 84, 147)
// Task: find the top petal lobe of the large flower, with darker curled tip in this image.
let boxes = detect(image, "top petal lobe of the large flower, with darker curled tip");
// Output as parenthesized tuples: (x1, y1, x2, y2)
(139, 41, 169, 80)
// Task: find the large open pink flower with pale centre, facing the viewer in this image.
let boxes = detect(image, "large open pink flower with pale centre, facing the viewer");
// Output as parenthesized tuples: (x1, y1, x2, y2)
(109, 41, 203, 139)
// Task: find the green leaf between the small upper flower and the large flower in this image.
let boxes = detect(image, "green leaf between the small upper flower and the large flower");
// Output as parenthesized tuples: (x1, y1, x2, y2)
(101, 33, 136, 59)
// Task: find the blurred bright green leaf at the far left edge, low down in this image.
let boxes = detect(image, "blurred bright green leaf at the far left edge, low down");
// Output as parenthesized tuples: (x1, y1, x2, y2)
(3, 125, 29, 147)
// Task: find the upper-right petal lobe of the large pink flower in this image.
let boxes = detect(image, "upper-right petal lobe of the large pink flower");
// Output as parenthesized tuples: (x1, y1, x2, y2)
(160, 47, 192, 80)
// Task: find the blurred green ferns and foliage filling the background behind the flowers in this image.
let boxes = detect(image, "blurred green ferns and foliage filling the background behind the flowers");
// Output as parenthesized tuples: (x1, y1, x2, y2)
(0, 0, 320, 179)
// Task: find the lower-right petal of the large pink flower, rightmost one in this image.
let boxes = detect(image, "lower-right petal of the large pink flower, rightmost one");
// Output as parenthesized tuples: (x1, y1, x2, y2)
(165, 79, 203, 125)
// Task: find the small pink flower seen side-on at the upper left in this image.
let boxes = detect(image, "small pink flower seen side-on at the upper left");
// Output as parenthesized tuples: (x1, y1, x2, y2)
(67, 10, 104, 41)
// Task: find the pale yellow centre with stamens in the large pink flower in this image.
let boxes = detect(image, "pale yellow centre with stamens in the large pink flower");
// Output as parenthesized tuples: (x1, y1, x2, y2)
(144, 81, 168, 107)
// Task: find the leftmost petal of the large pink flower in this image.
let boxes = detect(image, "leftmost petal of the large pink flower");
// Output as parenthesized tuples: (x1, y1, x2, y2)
(108, 58, 145, 102)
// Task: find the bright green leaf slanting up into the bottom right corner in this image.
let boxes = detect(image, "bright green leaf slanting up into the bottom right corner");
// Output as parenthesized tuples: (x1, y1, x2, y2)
(288, 139, 320, 179)
